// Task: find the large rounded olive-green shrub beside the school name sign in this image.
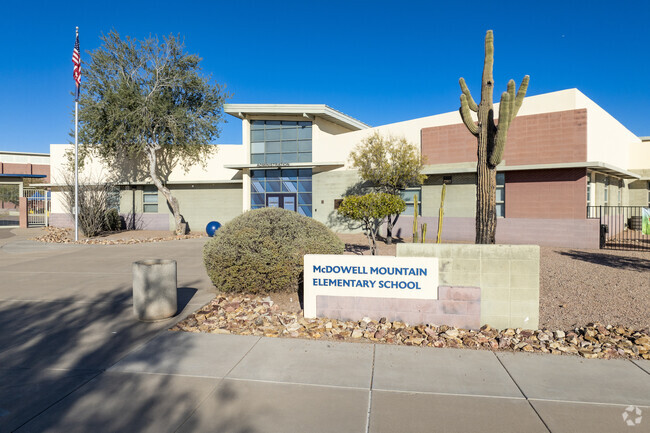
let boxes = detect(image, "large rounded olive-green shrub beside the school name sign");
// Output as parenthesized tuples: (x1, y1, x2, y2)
(203, 208, 345, 293)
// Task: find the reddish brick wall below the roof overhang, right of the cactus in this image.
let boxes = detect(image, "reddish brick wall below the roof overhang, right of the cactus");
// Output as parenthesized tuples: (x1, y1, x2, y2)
(506, 168, 587, 219)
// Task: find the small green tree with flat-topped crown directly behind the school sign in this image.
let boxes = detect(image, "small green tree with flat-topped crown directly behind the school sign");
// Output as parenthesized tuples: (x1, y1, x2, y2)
(337, 192, 406, 256)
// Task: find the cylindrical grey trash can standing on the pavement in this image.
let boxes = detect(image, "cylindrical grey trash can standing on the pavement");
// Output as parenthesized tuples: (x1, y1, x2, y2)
(132, 259, 178, 322)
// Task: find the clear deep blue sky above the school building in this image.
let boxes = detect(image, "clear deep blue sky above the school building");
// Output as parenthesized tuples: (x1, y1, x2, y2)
(0, 0, 650, 152)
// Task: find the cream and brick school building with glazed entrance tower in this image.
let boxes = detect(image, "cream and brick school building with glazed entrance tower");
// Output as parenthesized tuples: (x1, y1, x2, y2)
(50, 89, 650, 248)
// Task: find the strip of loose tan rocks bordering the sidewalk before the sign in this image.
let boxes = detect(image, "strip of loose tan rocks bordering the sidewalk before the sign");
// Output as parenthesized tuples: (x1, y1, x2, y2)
(172, 295, 650, 359)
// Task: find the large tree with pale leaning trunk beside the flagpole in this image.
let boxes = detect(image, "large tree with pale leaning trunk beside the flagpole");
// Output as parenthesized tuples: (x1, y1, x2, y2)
(79, 31, 229, 234)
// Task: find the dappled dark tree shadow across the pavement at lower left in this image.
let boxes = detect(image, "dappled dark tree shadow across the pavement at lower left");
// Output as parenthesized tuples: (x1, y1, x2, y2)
(0, 287, 246, 432)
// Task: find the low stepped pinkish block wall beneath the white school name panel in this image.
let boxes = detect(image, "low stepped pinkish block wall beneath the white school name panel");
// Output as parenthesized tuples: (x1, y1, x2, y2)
(316, 286, 481, 329)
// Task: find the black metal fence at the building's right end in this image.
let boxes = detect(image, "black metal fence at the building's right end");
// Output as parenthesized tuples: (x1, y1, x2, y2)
(587, 206, 650, 251)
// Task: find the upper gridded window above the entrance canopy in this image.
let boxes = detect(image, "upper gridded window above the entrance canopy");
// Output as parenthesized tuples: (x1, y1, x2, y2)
(251, 120, 311, 164)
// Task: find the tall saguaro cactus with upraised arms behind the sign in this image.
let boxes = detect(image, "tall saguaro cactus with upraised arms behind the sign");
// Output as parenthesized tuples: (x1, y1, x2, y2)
(459, 30, 530, 244)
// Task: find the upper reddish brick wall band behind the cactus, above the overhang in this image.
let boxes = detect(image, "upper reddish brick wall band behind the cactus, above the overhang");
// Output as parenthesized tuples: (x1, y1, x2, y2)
(421, 109, 587, 166)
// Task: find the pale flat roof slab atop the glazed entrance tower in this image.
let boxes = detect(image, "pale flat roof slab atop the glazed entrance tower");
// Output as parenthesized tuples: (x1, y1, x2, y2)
(223, 104, 370, 131)
